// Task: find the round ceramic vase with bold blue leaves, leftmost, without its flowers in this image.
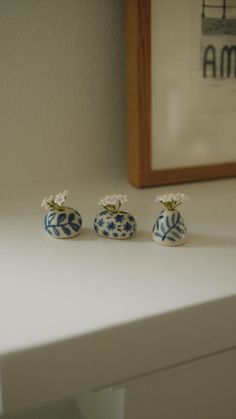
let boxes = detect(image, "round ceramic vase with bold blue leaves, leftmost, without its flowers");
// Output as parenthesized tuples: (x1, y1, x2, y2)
(44, 207, 82, 239)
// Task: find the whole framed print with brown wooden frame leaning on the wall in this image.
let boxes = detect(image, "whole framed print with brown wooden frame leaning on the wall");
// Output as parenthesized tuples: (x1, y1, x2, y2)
(126, 0, 236, 187)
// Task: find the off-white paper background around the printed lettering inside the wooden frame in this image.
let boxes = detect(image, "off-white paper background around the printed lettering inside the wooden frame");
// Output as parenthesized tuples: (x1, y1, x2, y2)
(151, 0, 236, 170)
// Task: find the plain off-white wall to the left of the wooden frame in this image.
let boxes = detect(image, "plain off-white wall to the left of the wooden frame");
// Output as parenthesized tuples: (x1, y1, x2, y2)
(0, 0, 127, 181)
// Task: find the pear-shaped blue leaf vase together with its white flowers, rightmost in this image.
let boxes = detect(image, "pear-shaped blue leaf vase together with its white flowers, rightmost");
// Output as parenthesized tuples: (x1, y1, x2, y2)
(152, 192, 189, 246)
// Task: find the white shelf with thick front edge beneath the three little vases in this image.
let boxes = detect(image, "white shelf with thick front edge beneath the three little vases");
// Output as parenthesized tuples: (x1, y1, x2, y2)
(0, 173, 236, 410)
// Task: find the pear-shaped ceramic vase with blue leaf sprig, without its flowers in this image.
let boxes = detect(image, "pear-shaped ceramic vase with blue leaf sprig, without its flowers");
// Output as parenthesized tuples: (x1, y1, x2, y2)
(152, 209, 187, 246)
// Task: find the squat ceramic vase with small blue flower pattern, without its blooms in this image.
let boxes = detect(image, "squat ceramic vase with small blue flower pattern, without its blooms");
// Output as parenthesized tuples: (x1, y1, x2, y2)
(94, 210, 137, 239)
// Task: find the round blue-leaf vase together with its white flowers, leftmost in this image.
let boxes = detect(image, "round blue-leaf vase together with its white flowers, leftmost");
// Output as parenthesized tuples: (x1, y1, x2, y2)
(41, 191, 82, 239)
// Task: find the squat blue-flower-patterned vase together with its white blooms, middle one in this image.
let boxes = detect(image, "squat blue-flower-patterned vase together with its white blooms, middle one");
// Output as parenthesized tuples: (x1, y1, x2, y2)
(94, 195, 137, 239)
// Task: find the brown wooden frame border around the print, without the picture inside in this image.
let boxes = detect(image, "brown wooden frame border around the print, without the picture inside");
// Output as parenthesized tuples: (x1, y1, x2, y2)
(126, 0, 236, 187)
